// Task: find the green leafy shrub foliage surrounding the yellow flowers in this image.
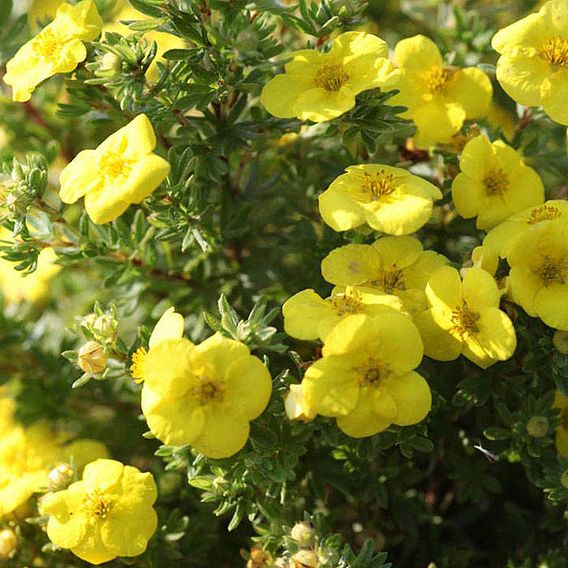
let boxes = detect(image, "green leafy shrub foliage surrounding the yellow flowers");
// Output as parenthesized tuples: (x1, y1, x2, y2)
(0, 0, 568, 568)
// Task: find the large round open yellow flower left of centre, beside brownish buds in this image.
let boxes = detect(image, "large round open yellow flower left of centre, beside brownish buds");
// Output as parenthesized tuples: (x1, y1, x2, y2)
(142, 333, 272, 458)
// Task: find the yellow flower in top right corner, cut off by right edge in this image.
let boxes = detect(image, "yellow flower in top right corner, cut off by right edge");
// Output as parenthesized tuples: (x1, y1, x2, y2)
(491, 0, 568, 124)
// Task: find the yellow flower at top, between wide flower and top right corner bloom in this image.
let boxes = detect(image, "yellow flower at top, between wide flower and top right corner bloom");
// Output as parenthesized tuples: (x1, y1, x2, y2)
(384, 35, 493, 148)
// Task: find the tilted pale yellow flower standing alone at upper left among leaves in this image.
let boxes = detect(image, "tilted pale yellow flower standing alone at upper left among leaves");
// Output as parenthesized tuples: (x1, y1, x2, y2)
(59, 114, 170, 224)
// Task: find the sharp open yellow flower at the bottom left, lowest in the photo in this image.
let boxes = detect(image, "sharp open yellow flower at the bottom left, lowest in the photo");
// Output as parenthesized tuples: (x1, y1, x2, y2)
(40, 459, 158, 564)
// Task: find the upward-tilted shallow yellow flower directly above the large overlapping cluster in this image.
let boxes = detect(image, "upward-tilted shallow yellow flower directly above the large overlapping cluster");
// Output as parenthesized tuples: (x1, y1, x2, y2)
(319, 164, 442, 235)
